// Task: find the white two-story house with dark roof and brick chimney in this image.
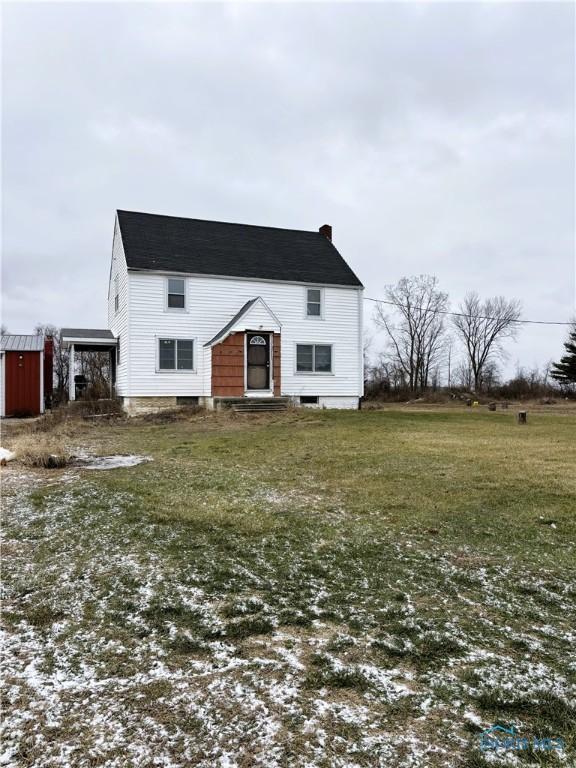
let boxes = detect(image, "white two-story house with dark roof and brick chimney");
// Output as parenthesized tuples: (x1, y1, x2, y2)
(97, 211, 363, 412)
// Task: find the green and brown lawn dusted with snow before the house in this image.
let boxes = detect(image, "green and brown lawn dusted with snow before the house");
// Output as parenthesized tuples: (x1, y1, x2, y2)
(4, 408, 576, 767)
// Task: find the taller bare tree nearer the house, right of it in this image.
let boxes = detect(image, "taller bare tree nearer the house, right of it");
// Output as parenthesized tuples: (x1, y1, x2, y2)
(374, 275, 448, 392)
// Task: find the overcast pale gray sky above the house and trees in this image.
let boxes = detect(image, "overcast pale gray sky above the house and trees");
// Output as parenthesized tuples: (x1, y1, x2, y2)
(2, 2, 575, 376)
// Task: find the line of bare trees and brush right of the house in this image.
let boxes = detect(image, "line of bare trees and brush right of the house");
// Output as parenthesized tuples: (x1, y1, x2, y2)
(365, 275, 576, 397)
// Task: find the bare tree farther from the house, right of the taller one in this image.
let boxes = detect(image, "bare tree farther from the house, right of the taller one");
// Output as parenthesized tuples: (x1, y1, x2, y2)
(452, 292, 522, 392)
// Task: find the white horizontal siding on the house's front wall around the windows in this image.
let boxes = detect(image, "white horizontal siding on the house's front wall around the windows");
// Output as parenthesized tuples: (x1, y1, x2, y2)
(120, 272, 363, 398)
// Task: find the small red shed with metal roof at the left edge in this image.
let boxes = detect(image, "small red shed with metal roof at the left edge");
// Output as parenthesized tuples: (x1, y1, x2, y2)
(0, 334, 52, 416)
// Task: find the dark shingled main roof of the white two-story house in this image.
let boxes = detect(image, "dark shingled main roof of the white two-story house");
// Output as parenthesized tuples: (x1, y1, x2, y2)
(118, 211, 362, 287)
